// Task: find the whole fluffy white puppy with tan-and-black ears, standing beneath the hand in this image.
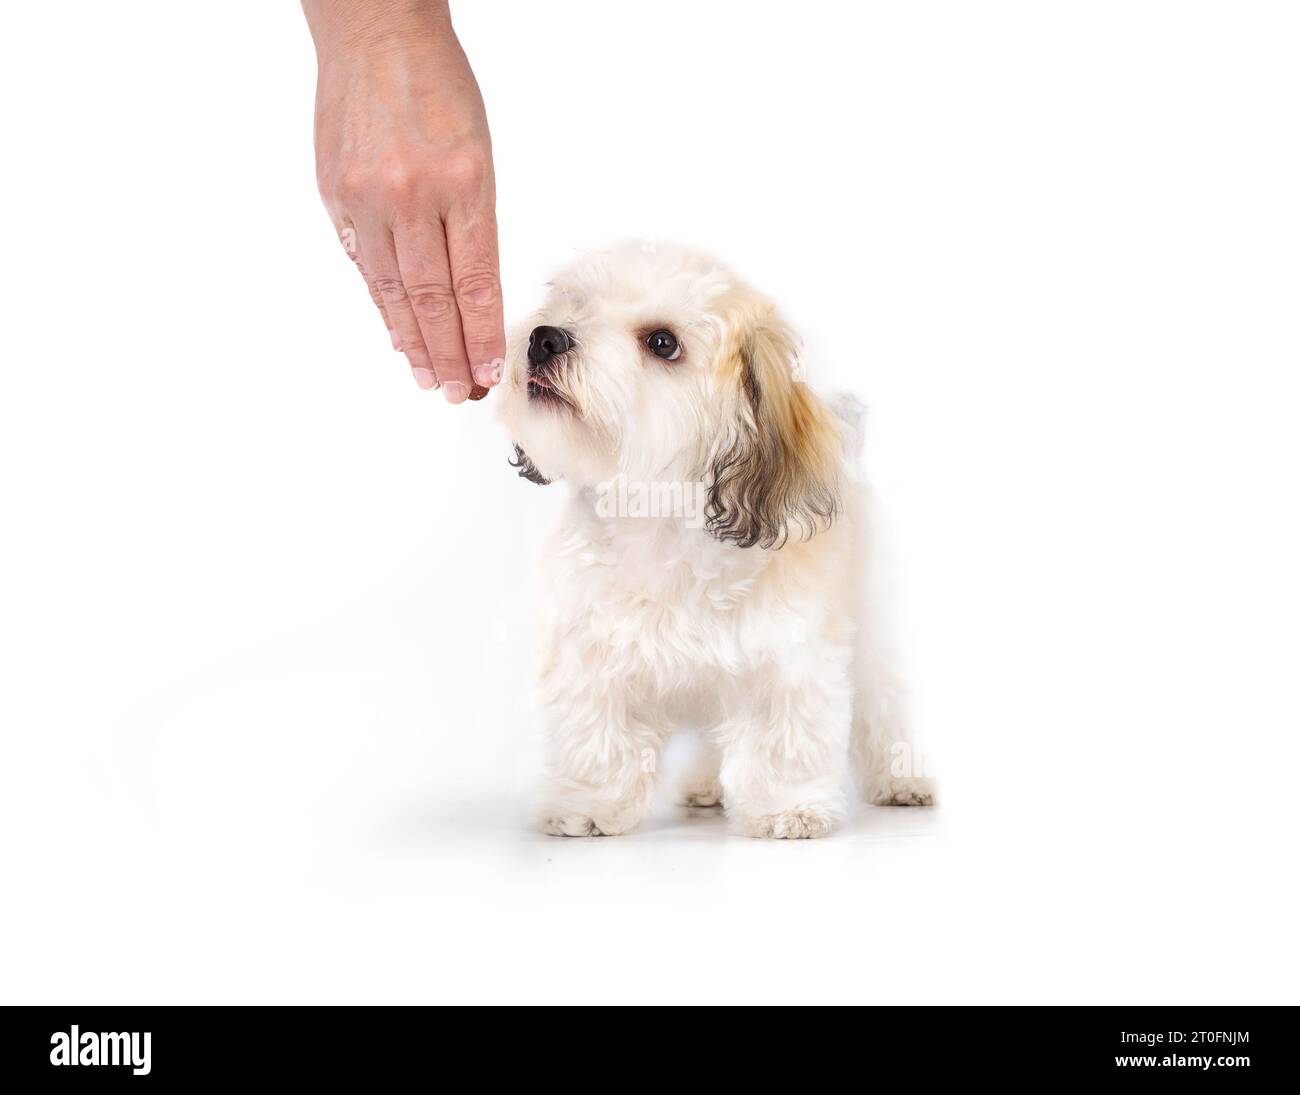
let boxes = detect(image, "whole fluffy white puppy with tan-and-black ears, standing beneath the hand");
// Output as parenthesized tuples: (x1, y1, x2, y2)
(501, 240, 933, 838)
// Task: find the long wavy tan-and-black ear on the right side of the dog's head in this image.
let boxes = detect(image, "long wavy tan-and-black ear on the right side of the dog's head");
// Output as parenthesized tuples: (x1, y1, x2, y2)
(705, 302, 841, 548)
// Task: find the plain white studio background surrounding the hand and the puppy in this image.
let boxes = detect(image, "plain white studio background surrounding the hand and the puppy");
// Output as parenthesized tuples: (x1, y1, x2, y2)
(0, 0, 1300, 1004)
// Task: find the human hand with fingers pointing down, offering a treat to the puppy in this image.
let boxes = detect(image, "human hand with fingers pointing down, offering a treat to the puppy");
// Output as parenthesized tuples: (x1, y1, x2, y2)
(303, 0, 506, 403)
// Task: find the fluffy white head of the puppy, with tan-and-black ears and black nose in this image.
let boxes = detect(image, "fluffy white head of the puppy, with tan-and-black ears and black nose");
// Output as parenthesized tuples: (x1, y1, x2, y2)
(499, 247, 841, 548)
